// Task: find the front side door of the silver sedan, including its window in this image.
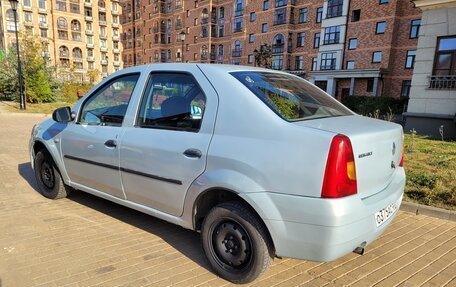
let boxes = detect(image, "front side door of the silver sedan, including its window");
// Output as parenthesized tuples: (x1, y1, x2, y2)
(61, 74, 139, 199)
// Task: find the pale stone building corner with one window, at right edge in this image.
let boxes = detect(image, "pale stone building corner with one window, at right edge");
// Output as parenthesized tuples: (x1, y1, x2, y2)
(405, 0, 456, 138)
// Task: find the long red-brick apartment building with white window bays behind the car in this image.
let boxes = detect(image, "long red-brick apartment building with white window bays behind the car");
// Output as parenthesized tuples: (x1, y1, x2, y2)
(121, 0, 421, 97)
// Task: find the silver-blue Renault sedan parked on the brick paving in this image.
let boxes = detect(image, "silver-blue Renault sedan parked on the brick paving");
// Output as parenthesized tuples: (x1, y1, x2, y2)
(30, 64, 405, 283)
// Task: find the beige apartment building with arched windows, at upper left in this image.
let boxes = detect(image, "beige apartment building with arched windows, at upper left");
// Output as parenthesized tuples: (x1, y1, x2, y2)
(0, 0, 122, 81)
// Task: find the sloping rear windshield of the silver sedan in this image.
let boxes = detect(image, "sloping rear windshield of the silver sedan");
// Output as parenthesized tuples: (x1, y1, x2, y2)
(231, 71, 353, 121)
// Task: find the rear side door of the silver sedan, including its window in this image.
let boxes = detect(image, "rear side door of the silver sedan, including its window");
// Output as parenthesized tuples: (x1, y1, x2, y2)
(120, 66, 218, 216)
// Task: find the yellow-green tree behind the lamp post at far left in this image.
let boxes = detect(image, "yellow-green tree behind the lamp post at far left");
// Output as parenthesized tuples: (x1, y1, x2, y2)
(0, 34, 56, 103)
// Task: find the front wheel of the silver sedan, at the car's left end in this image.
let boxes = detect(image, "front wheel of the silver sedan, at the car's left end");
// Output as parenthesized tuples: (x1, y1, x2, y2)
(34, 150, 72, 199)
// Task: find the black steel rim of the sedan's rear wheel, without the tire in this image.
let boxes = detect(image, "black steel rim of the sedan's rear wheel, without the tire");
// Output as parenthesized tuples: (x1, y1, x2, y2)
(209, 218, 252, 272)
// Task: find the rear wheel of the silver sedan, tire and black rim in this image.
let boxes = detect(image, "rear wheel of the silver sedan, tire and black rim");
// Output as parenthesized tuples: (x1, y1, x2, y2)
(201, 202, 274, 284)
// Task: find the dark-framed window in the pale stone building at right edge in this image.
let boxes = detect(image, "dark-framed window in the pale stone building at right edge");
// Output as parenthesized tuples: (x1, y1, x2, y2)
(432, 36, 456, 76)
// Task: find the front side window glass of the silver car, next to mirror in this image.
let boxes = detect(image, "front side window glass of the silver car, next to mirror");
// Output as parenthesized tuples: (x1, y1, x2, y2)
(79, 74, 139, 126)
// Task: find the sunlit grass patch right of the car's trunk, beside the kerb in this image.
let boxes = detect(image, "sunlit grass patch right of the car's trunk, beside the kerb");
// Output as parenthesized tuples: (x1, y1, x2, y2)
(404, 134, 456, 210)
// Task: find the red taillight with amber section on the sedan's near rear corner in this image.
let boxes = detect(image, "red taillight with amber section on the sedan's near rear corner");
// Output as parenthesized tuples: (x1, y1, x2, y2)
(321, 134, 357, 198)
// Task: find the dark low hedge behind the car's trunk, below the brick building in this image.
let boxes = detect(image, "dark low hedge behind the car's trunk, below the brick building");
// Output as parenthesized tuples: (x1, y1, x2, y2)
(342, 96, 408, 116)
